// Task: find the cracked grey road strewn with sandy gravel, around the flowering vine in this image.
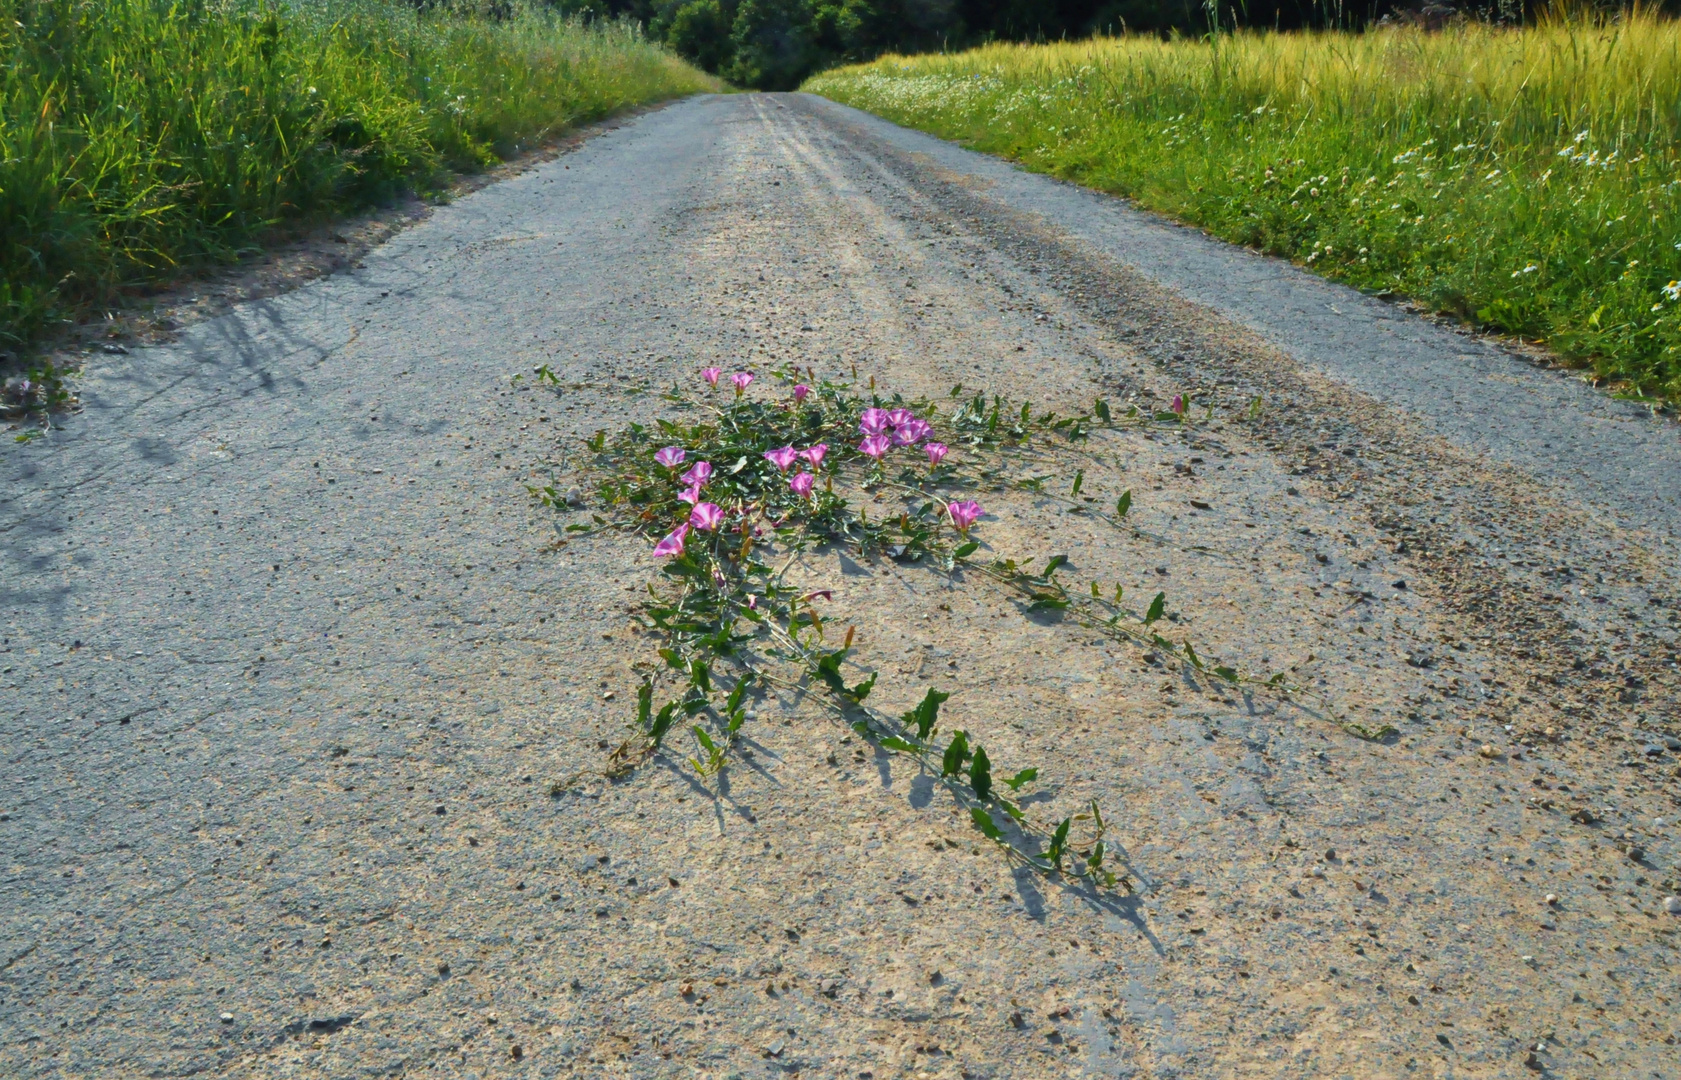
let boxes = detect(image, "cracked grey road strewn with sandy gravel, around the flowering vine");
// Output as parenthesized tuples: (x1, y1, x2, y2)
(0, 94, 1681, 1080)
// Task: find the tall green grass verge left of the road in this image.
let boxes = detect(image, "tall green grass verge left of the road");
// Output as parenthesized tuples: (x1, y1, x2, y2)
(0, 0, 716, 343)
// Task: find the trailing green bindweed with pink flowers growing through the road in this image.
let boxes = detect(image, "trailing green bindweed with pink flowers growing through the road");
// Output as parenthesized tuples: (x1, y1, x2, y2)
(530, 367, 1365, 887)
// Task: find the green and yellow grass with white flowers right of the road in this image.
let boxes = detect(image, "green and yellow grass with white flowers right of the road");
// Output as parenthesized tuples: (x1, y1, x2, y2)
(807, 13, 1681, 399)
